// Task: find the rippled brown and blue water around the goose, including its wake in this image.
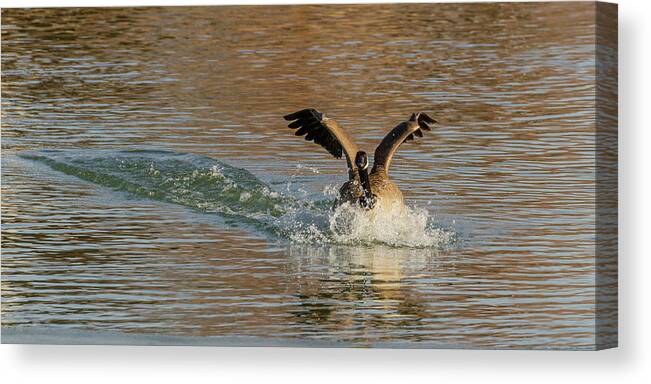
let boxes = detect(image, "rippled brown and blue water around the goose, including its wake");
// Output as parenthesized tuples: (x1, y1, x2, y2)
(2, 3, 616, 349)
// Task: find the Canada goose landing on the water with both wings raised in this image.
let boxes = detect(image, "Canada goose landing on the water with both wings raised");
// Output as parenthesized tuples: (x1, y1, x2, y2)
(284, 109, 437, 209)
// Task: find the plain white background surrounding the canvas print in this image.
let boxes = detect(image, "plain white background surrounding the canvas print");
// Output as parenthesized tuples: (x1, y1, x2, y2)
(0, 0, 651, 384)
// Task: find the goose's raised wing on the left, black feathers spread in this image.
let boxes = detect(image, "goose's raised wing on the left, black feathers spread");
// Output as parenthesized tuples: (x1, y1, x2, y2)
(283, 109, 357, 171)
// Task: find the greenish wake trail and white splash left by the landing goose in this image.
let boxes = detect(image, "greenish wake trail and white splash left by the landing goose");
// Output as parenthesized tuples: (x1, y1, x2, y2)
(20, 150, 456, 248)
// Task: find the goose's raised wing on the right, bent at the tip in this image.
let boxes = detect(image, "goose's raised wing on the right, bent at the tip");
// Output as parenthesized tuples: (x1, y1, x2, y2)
(373, 113, 437, 173)
